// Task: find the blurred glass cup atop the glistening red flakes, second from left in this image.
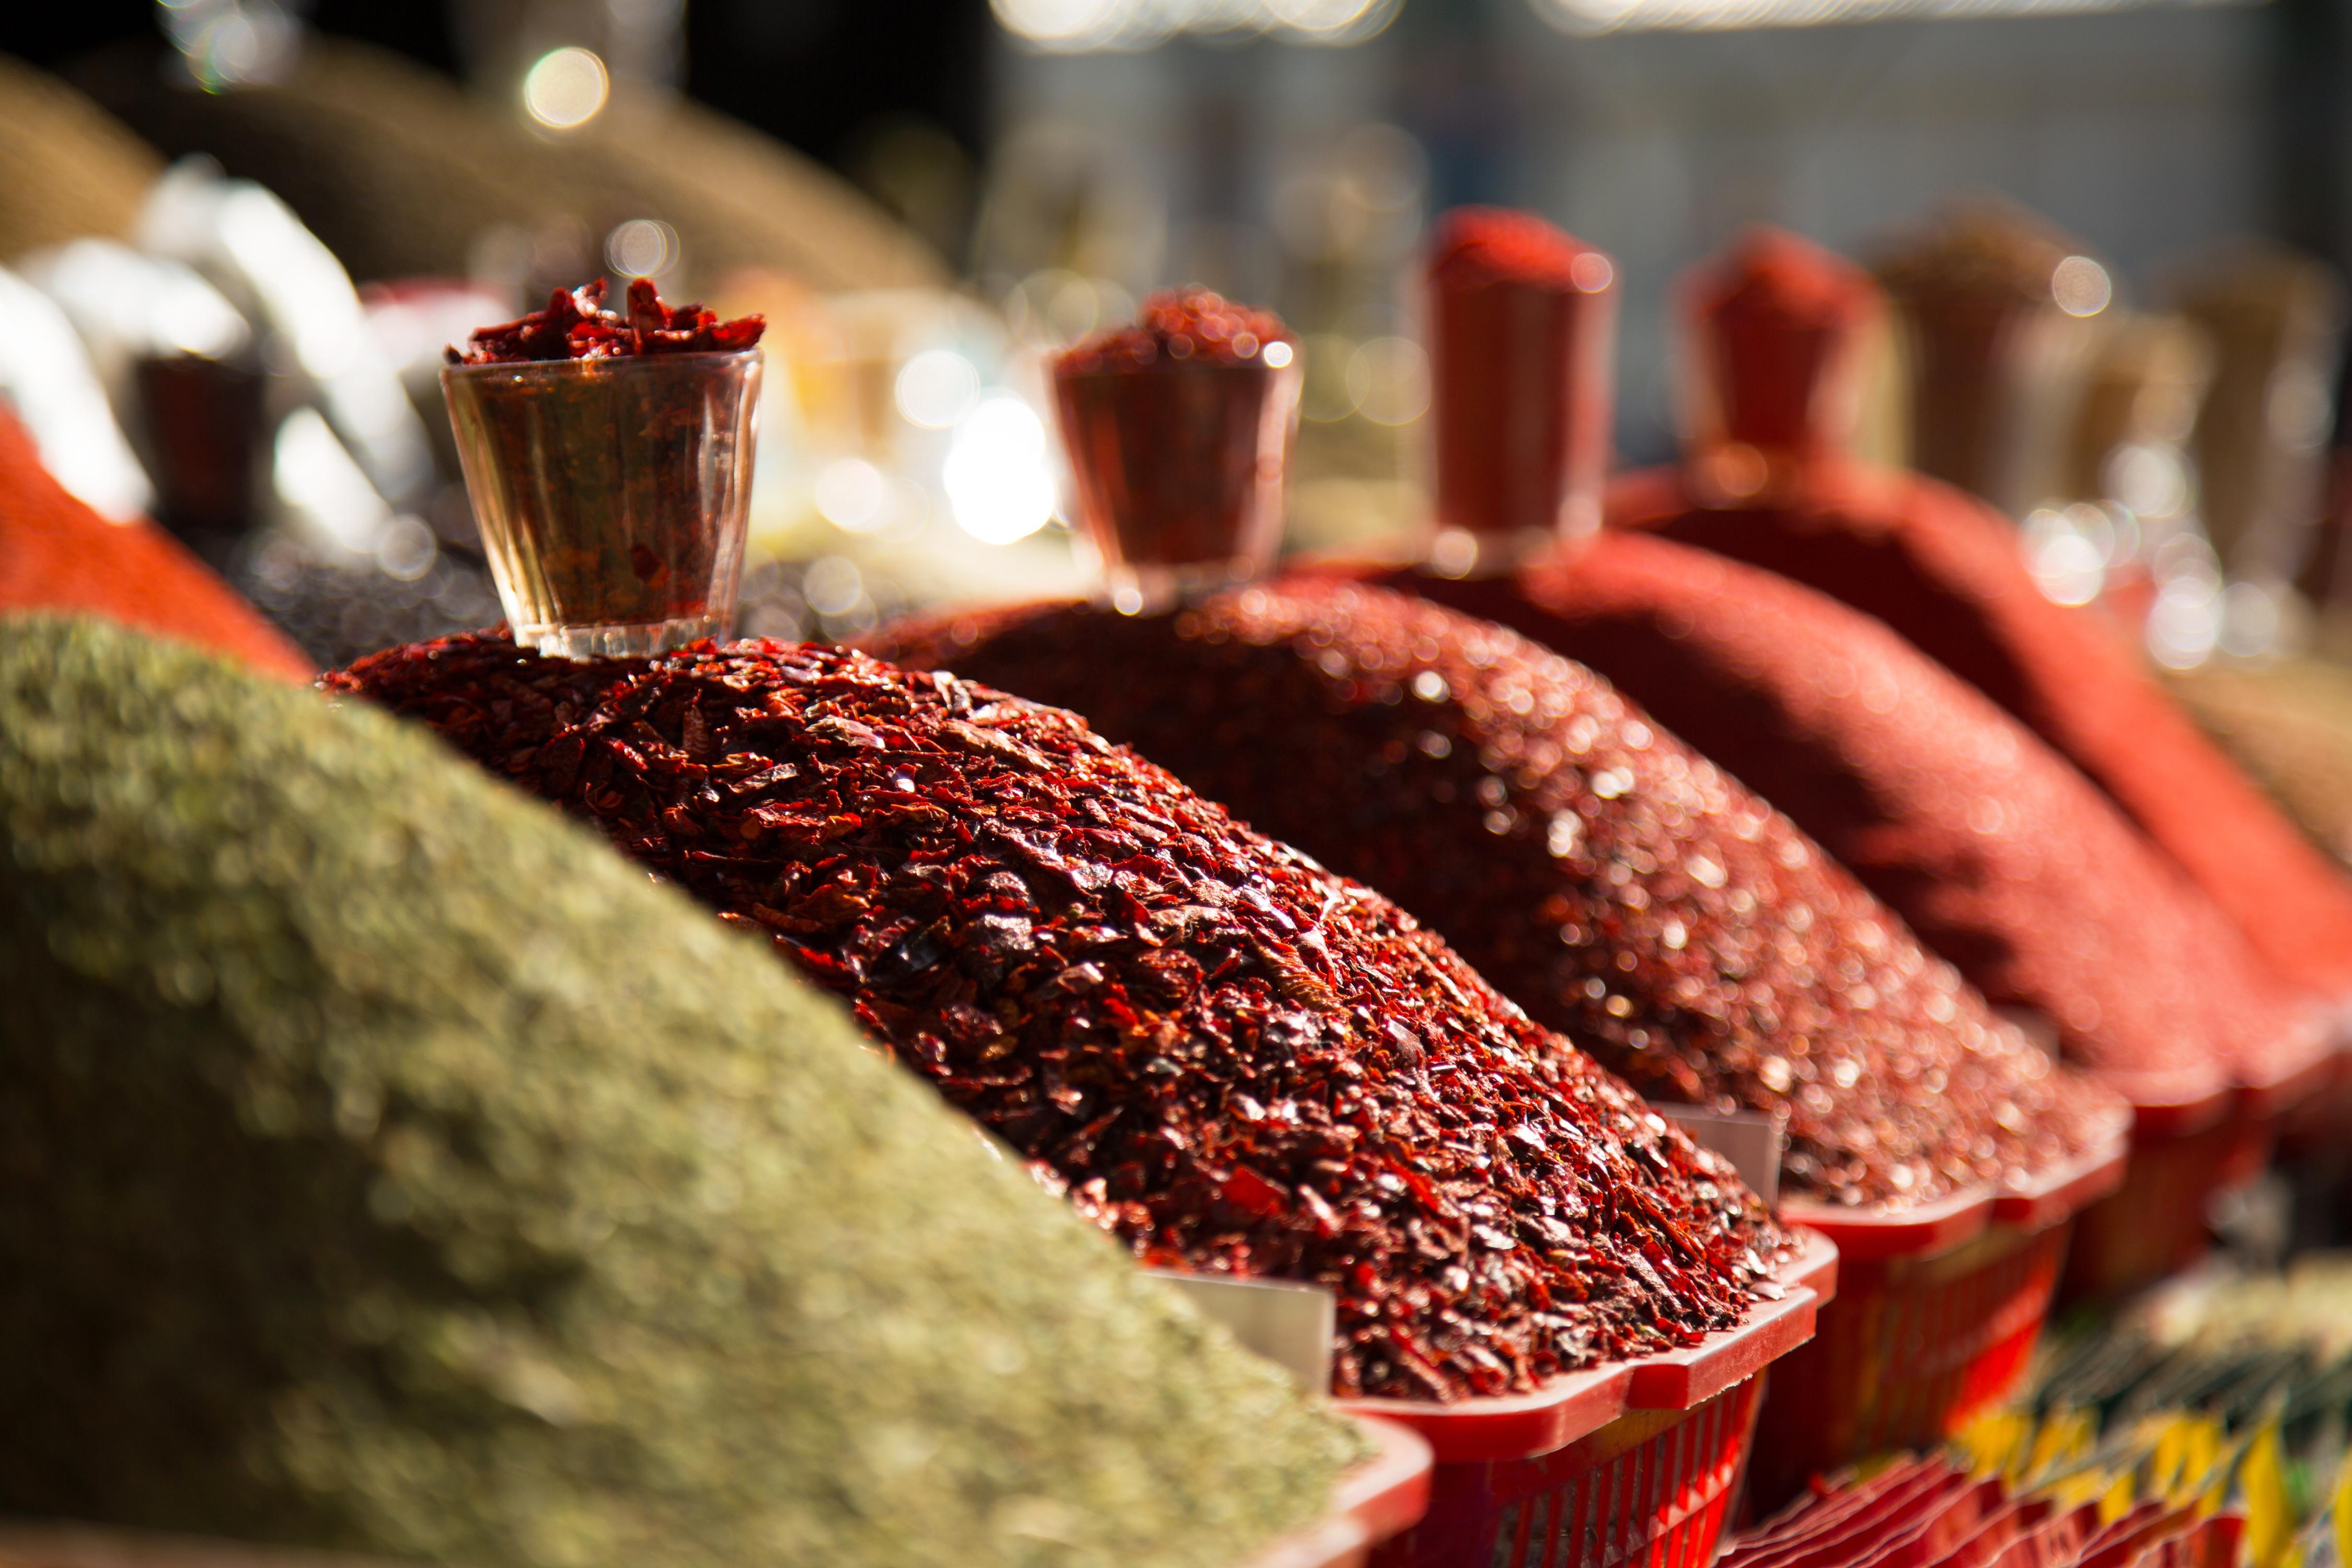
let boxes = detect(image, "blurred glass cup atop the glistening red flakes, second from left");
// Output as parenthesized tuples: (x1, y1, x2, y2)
(1054, 289, 1303, 614)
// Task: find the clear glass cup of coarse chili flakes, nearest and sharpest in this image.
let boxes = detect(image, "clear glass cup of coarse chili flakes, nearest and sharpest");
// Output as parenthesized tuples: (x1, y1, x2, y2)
(442, 278, 765, 658)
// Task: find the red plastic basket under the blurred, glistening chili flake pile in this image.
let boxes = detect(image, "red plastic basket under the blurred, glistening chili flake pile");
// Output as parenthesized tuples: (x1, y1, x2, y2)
(1748, 1143, 2126, 1512)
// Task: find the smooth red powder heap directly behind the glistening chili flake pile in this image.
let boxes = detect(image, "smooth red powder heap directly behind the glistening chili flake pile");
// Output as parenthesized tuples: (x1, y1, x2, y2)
(1419, 531, 2317, 1105)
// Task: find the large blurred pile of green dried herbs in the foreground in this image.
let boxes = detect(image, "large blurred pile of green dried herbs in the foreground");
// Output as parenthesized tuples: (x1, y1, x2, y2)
(0, 618, 1357, 1568)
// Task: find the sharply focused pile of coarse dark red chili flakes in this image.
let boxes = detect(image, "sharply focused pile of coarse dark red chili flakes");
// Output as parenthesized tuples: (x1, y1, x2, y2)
(325, 635, 1783, 1399)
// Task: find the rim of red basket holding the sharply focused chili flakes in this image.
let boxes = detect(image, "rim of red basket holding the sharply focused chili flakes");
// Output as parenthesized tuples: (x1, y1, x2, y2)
(1334, 1229, 1837, 1465)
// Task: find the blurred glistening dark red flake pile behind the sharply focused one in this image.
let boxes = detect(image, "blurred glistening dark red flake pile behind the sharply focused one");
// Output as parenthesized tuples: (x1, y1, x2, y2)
(878, 581, 2126, 1206)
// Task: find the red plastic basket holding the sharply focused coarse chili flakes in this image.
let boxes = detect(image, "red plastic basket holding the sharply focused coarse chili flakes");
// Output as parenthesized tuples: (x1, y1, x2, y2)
(1343, 1234, 1837, 1568)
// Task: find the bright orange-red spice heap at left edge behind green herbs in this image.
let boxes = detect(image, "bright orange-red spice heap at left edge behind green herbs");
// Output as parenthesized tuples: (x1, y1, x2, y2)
(0, 407, 315, 679)
